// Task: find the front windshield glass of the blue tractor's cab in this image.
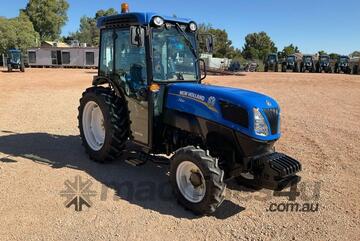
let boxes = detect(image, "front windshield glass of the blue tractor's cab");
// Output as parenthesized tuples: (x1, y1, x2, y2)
(152, 26, 198, 82)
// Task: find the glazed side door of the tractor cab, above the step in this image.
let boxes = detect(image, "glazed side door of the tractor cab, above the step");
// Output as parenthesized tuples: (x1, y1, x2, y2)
(112, 28, 149, 146)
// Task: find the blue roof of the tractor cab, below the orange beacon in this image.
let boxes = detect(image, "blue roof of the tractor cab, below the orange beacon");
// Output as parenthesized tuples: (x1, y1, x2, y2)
(97, 12, 191, 28)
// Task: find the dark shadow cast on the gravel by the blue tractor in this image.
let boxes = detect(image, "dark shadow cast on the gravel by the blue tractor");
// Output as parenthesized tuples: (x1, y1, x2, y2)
(0, 131, 244, 219)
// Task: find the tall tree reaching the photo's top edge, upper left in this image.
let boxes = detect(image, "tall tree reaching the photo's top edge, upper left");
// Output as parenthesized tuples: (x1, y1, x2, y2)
(25, 0, 69, 41)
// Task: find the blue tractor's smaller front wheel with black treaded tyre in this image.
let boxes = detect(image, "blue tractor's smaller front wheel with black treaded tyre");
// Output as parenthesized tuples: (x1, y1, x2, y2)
(170, 146, 226, 215)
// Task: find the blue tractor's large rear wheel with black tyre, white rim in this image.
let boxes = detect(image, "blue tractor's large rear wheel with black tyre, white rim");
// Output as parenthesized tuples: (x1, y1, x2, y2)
(78, 87, 131, 163)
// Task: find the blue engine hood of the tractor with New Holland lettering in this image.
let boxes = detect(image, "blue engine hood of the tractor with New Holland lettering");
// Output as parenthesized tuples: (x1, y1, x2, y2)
(166, 83, 280, 141)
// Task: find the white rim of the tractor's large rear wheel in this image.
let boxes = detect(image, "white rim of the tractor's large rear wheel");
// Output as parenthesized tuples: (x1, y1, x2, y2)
(82, 101, 105, 151)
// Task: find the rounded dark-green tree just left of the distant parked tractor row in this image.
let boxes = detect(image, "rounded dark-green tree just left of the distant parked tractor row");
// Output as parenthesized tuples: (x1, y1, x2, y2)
(242, 32, 277, 59)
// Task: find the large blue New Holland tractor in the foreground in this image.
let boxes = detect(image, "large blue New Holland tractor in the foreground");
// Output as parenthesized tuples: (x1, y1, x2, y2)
(78, 5, 301, 215)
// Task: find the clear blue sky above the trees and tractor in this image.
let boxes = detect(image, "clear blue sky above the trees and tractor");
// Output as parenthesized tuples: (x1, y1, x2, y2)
(0, 0, 360, 54)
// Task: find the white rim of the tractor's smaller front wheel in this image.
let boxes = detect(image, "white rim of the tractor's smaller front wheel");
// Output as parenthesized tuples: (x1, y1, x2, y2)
(176, 161, 206, 203)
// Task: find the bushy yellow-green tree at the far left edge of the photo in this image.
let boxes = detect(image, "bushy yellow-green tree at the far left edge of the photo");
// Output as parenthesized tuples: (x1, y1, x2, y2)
(0, 11, 39, 53)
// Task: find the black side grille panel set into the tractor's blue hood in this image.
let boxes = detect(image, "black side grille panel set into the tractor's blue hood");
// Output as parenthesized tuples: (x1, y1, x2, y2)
(220, 101, 249, 128)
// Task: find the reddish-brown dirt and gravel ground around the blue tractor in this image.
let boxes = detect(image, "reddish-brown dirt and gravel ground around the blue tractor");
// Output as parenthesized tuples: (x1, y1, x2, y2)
(0, 69, 360, 240)
